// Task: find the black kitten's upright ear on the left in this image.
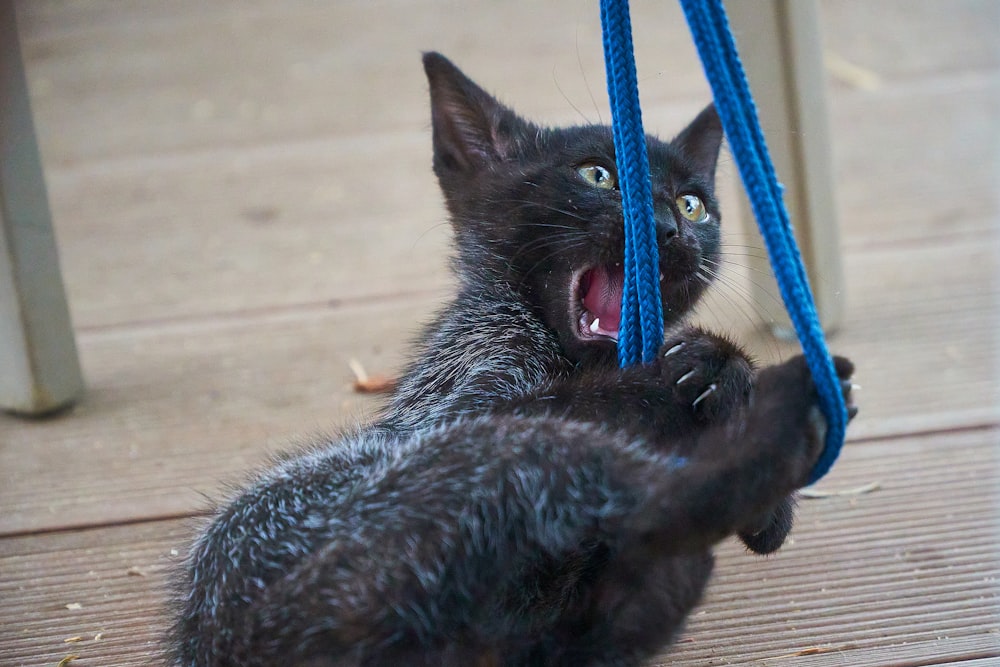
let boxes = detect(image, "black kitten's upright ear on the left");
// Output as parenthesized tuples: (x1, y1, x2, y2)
(424, 52, 530, 175)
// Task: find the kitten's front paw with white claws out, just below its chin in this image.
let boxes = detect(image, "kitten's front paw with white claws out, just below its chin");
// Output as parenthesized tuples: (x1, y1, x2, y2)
(660, 328, 754, 422)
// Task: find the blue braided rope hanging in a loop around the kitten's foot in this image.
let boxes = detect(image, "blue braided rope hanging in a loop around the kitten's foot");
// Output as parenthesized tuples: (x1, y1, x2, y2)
(601, 0, 847, 484)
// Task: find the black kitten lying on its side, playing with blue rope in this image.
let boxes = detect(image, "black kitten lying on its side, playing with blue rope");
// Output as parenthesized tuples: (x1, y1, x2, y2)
(170, 53, 852, 667)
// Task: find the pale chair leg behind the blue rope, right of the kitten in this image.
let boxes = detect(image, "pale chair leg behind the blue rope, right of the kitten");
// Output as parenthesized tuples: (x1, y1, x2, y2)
(726, 0, 844, 334)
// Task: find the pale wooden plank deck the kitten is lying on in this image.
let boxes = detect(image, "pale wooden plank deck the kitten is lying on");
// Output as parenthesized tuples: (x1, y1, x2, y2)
(0, 0, 1000, 667)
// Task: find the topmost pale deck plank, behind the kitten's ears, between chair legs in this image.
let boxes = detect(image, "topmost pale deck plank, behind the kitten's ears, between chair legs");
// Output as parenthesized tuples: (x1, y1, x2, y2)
(13, 0, 708, 164)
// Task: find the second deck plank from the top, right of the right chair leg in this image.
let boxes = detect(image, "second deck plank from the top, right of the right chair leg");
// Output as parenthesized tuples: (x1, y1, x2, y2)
(831, 79, 1000, 252)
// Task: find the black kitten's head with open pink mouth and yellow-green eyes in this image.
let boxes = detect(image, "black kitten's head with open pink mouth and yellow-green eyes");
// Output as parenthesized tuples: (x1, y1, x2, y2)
(424, 53, 722, 361)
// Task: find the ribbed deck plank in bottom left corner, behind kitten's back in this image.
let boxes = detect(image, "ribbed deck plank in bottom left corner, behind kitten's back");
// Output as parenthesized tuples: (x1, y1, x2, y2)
(0, 521, 187, 667)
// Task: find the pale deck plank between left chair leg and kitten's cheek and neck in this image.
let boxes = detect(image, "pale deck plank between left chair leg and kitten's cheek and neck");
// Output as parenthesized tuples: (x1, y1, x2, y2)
(44, 134, 450, 331)
